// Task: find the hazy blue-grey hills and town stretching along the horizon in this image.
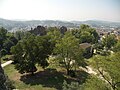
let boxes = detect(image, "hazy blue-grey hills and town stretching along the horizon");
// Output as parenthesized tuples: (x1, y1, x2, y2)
(0, 18, 120, 31)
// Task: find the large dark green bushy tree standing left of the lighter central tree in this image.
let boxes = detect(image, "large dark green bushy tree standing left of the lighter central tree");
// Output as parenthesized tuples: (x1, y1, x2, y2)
(11, 35, 51, 74)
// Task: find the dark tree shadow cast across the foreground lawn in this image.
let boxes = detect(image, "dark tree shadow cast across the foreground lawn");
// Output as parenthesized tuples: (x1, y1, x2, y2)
(20, 69, 89, 90)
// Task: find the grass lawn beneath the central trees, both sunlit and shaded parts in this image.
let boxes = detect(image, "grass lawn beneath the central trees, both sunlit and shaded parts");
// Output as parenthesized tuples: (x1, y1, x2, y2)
(4, 60, 88, 90)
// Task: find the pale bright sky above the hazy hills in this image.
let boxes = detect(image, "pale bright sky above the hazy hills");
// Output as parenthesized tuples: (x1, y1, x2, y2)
(0, 0, 120, 22)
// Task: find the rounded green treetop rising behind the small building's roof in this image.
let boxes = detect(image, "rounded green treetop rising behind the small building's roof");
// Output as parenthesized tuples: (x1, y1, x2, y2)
(72, 24, 99, 44)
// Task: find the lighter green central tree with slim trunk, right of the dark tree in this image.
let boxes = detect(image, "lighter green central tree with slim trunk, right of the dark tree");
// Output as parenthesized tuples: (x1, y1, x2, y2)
(55, 32, 83, 75)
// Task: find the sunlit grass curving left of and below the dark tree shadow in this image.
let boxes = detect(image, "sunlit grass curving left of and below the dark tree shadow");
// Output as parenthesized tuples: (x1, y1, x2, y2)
(4, 64, 56, 90)
